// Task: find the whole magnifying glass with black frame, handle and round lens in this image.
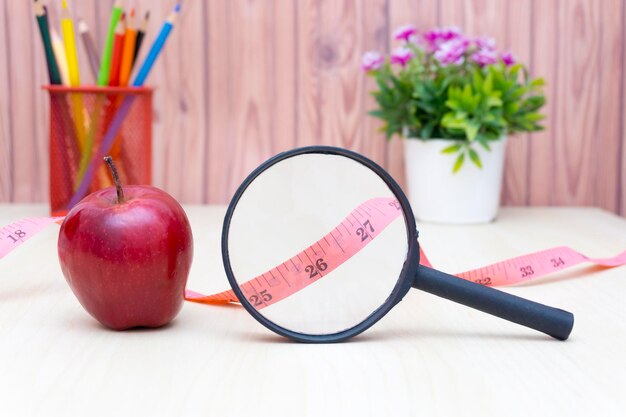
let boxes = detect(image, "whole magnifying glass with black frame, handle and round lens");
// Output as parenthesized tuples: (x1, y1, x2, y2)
(222, 146, 574, 343)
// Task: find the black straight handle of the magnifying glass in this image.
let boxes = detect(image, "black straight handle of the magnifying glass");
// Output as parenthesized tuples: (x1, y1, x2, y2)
(413, 265, 574, 340)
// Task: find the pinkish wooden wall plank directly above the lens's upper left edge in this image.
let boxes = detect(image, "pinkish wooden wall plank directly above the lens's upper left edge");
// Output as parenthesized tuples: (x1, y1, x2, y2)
(207, 0, 296, 203)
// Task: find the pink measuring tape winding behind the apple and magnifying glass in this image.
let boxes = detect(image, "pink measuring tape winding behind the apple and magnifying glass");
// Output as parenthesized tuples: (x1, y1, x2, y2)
(0, 198, 626, 309)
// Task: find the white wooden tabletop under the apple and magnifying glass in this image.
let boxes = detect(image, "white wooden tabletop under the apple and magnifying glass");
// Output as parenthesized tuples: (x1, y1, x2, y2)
(0, 205, 626, 417)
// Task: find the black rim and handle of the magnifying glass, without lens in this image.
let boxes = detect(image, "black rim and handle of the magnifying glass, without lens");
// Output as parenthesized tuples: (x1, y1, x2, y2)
(222, 146, 574, 343)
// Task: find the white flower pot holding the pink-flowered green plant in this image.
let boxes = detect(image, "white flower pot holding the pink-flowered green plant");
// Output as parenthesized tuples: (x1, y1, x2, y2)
(403, 137, 506, 224)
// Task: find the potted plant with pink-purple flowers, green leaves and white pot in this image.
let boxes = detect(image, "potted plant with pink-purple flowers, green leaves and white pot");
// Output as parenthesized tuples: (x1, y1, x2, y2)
(362, 26, 545, 223)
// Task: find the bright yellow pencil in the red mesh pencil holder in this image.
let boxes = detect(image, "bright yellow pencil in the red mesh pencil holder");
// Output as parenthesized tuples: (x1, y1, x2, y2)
(61, 0, 90, 154)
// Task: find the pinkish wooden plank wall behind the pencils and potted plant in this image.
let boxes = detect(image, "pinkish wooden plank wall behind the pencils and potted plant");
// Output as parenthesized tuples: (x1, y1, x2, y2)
(0, 0, 626, 214)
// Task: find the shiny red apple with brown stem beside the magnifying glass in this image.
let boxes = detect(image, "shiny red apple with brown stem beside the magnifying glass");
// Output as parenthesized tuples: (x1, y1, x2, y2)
(58, 157, 193, 330)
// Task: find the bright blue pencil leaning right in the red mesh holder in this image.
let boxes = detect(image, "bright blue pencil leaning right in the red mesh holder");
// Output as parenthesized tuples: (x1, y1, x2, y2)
(69, 4, 180, 207)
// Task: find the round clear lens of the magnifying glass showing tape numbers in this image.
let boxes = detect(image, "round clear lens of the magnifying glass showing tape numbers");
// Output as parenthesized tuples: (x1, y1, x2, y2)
(227, 153, 408, 335)
